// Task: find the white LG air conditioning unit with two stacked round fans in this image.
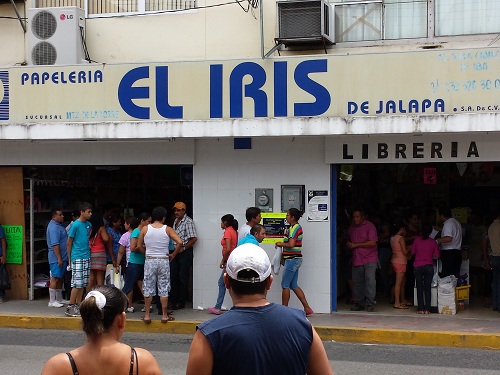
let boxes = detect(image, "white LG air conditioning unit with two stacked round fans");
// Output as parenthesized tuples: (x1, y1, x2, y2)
(27, 7, 87, 65)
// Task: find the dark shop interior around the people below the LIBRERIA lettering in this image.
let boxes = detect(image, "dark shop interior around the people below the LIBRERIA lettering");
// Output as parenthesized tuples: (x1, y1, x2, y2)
(337, 162, 500, 314)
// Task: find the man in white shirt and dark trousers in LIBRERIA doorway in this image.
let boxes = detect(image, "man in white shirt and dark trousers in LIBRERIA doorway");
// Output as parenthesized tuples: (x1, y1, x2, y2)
(436, 207, 462, 277)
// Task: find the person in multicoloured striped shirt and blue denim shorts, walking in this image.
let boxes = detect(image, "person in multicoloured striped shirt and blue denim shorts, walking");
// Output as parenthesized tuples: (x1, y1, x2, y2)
(274, 208, 313, 315)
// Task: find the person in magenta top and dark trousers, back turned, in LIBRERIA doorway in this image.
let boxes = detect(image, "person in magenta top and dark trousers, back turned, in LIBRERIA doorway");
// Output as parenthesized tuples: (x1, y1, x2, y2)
(411, 225, 440, 314)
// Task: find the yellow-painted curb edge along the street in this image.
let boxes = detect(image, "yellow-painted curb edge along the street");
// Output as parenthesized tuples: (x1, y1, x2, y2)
(0, 315, 500, 350)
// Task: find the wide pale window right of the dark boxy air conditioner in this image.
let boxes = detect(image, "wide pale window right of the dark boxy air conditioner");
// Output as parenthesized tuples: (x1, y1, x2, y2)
(330, 0, 500, 43)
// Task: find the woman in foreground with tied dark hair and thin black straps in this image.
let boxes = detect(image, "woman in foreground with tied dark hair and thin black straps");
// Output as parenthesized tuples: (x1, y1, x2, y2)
(42, 285, 161, 375)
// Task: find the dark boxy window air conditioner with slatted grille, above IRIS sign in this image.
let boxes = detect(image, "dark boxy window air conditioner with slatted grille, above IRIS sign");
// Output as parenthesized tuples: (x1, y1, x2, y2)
(275, 0, 335, 45)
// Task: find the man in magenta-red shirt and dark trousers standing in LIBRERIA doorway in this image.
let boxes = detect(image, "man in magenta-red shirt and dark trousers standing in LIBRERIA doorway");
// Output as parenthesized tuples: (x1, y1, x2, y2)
(347, 208, 378, 312)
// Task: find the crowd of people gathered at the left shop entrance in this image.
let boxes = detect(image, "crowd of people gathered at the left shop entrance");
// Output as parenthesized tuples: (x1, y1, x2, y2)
(47, 202, 197, 323)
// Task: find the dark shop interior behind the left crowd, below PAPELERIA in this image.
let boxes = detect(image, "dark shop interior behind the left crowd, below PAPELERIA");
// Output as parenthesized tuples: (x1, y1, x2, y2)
(23, 165, 193, 298)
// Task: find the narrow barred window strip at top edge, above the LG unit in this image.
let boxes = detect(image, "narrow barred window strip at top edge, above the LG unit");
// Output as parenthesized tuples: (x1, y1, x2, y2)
(35, 0, 197, 18)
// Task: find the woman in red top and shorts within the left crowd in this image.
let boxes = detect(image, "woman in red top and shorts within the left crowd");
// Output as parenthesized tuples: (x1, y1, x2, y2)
(88, 213, 109, 290)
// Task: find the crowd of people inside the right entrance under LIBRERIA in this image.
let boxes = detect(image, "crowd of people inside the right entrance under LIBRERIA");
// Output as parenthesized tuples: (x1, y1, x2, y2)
(339, 206, 500, 314)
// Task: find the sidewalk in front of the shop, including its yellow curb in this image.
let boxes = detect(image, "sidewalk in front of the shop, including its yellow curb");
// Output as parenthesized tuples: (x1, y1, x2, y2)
(0, 299, 500, 349)
